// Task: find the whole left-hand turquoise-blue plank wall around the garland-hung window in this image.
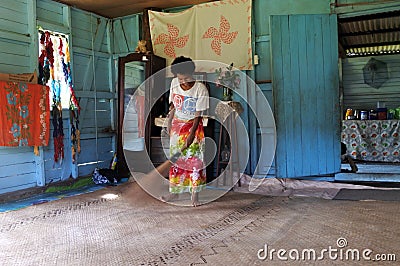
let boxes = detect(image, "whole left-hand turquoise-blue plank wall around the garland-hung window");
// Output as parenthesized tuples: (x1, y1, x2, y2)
(0, 0, 130, 194)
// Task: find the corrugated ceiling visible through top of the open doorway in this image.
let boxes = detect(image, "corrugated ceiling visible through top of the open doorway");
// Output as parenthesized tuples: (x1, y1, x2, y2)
(338, 11, 400, 57)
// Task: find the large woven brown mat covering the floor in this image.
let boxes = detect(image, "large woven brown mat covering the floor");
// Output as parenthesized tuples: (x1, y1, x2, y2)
(0, 183, 400, 265)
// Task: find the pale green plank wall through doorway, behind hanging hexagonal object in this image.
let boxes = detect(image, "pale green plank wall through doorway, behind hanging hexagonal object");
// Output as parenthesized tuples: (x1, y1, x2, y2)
(342, 55, 400, 112)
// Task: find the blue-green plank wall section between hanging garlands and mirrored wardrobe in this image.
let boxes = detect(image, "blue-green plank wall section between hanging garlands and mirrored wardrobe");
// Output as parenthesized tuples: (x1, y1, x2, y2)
(71, 9, 116, 176)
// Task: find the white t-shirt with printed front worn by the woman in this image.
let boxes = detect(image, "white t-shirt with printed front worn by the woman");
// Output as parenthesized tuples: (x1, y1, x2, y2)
(169, 78, 209, 120)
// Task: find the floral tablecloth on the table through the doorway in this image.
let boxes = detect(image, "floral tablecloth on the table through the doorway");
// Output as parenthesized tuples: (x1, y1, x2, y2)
(342, 120, 400, 162)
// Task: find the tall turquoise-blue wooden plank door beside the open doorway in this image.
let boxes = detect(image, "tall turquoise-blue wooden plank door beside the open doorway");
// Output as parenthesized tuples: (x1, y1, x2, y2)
(270, 15, 340, 178)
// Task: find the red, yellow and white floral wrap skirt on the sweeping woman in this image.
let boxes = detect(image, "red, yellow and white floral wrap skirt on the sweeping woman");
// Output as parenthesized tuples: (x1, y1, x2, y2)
(169, 119, 207, 193)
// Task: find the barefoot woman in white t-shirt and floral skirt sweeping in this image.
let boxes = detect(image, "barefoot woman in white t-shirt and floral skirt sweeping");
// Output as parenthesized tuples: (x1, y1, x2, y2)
(162, 56, 209, 206)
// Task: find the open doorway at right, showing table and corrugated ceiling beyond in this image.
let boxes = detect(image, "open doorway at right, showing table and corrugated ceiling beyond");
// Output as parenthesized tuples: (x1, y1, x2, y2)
(335, 11, 400, 182)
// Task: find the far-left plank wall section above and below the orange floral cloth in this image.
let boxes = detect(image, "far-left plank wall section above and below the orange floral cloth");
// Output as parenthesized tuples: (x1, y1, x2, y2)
(0, 0, 36, 194)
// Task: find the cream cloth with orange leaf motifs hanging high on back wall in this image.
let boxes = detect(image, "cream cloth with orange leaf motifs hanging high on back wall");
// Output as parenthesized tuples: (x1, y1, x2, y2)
(148, 0, 253, 72)
